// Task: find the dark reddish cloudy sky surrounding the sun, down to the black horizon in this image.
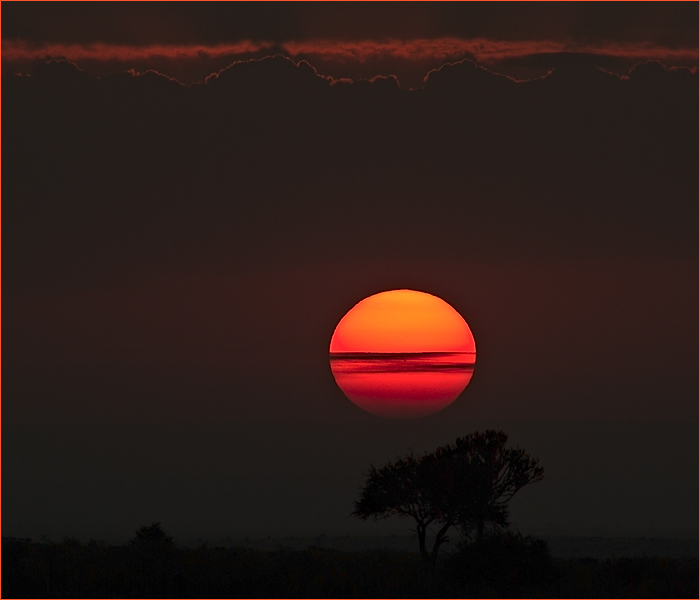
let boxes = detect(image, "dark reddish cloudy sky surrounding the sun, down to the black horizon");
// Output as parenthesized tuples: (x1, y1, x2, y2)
(2, 2, 698, 541)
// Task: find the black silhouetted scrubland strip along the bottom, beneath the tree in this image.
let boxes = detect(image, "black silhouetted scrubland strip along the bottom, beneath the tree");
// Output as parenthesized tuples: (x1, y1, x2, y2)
(2, 536, 698, 598)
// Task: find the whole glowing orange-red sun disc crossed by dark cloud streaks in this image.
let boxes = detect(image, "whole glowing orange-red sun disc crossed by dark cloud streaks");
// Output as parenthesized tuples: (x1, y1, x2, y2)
(330, 290, 476, 418)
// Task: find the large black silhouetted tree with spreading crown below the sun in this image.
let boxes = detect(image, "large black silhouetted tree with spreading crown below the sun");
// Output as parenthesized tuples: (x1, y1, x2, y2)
(352, 431, 544, 567)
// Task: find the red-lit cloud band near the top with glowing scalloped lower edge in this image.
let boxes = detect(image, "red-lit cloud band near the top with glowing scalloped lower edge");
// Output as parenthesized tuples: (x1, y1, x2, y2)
(2, 37, 697, 87)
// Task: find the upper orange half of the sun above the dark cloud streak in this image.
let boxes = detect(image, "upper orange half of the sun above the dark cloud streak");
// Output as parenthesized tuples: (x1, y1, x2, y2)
(330, 289, 476, 353)
